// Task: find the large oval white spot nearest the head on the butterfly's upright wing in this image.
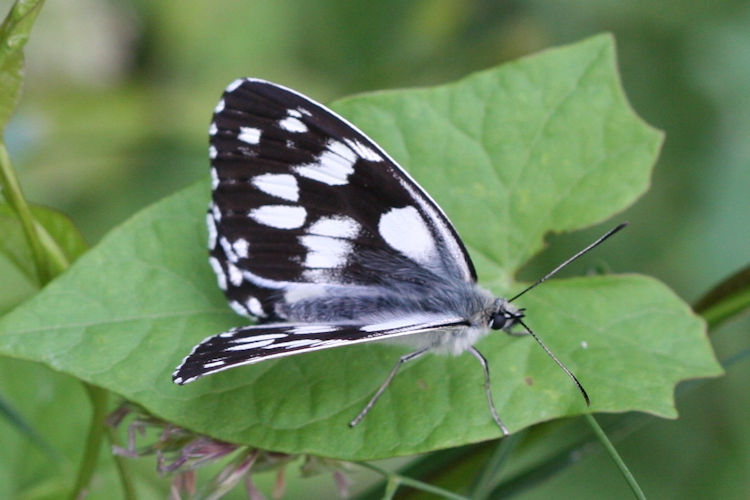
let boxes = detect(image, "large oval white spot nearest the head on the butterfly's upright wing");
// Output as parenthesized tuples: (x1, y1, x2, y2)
(378, 206, 440, 267)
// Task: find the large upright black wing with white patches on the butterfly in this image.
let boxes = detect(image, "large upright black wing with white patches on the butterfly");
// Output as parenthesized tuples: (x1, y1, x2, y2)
(207, 79, 476, 322)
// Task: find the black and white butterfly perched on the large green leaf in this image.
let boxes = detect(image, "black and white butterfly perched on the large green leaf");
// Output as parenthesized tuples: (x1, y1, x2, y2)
(172, 78, 624, 435)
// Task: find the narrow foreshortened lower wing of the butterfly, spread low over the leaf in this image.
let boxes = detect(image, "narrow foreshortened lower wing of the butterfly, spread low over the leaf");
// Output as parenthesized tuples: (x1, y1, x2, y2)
(172, 314, 468, 384)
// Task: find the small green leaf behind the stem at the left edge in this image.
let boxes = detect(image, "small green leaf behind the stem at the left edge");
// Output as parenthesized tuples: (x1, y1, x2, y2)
(0, 202, 86, 315)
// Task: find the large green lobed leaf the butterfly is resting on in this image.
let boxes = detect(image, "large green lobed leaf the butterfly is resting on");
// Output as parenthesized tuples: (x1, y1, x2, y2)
(0, 36, 721, 459)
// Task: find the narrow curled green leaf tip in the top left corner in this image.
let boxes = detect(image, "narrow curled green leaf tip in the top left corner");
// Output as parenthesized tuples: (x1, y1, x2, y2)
(0, 0, 44, 132)
